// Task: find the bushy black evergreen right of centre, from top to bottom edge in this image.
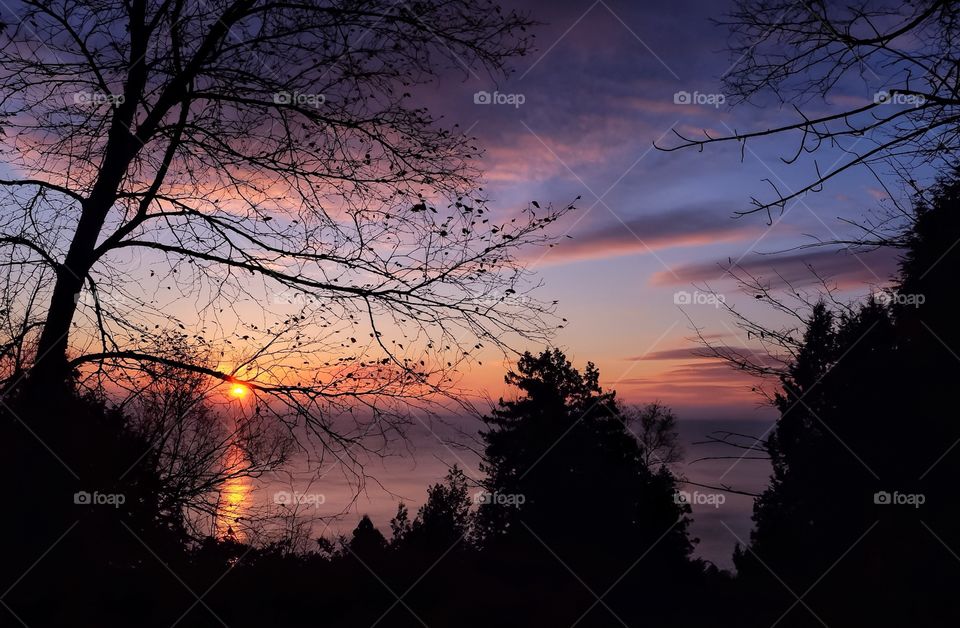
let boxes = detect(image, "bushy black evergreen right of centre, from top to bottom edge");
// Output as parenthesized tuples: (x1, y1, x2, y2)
(477, 349, 693, 625)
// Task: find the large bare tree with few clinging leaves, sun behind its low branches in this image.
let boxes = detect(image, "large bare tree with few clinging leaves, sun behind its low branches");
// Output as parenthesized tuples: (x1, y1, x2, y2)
(0, 0, 572, 456)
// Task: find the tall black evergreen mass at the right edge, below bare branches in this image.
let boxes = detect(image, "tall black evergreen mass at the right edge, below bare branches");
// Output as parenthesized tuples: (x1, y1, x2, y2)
(736, 172, 960, 626)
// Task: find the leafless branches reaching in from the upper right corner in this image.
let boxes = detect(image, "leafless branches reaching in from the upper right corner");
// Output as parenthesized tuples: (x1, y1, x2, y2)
(662, 0, 960, 221)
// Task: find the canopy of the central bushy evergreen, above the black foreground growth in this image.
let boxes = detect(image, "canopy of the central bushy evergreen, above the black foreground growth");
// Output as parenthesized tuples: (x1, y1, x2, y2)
(480, 349, 691, 557)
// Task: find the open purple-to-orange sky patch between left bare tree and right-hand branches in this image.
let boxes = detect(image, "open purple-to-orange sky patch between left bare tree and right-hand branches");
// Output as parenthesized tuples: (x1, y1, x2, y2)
(410, 1, 908, 418)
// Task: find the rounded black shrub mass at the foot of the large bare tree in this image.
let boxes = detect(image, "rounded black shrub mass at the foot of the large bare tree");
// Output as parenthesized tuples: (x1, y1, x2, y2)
(0, 395, 200, 625)
